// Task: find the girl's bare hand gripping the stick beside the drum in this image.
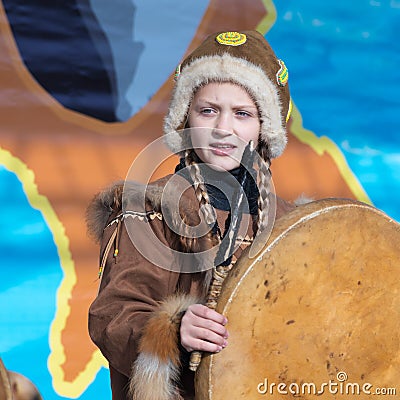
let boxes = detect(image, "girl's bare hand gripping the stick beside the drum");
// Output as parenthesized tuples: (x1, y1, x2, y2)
(180, 304, 228, 353)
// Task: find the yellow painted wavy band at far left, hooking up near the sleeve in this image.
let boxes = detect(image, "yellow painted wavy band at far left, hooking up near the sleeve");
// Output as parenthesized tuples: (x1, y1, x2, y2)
(0, 147, 108, 398)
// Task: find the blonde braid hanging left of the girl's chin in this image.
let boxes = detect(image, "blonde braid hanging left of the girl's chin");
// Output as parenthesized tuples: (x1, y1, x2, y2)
(185, 149, 216, 225)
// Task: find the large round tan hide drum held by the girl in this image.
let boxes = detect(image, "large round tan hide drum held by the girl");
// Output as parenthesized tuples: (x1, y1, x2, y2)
(195, 199, 400, 400)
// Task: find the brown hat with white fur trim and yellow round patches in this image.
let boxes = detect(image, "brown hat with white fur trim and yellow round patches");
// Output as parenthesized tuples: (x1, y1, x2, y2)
(164, 31, 291, 159)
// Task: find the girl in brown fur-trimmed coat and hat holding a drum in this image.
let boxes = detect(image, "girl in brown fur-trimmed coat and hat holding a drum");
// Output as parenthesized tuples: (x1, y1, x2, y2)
(88, 31, 293, 400)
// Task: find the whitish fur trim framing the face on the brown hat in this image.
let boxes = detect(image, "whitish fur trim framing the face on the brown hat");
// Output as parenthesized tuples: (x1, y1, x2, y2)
(164, 53, 287, 158)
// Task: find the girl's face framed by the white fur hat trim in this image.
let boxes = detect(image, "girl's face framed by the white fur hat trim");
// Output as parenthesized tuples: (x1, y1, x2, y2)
(188, 82, 260, 171)
